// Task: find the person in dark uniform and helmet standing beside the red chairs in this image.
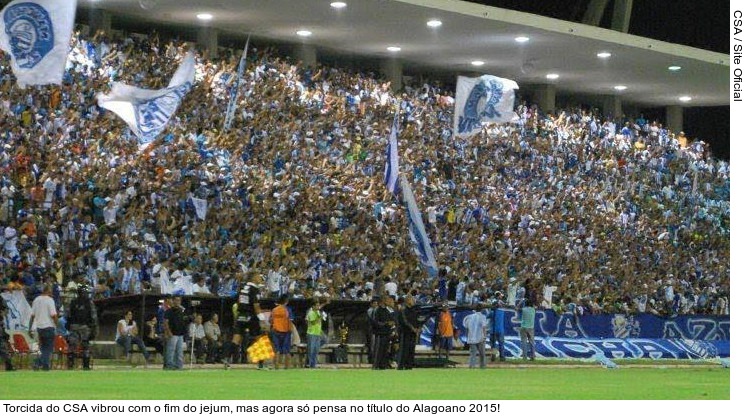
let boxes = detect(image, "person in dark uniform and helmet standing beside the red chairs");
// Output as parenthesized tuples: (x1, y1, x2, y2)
(66, 284, 98, 370)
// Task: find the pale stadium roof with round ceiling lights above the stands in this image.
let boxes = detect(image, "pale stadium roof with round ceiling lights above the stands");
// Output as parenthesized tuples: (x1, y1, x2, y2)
(80, 0, 729, 106)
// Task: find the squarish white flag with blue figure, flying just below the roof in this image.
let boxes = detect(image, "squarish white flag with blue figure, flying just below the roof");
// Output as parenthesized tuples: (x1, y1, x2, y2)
(455, 75, 519, 138)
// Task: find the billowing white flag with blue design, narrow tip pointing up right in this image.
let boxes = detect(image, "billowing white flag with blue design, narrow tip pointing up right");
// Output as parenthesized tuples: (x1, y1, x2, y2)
(98, 53, 196, 149)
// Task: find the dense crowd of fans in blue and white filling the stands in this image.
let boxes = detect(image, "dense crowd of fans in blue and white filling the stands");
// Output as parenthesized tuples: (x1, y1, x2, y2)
(0, 27, 730, 322)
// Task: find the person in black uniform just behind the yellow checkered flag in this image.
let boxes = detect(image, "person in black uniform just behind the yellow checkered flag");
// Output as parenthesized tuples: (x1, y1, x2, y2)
(223, 274, 263, 368)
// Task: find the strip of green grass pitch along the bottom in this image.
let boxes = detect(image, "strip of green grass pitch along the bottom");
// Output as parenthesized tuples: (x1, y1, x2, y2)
(0, 365, 730, 400)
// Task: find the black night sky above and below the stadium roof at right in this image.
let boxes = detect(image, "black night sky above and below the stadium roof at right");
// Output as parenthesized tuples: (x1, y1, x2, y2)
(471, 0, 731, 160)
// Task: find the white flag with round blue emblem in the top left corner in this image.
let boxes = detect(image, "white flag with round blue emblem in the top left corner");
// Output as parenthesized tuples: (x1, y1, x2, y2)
(0, 0, 77, 87)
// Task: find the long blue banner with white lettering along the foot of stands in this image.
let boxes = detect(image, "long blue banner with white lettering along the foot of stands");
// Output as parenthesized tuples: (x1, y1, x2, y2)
(420, 309, 731, 359)
